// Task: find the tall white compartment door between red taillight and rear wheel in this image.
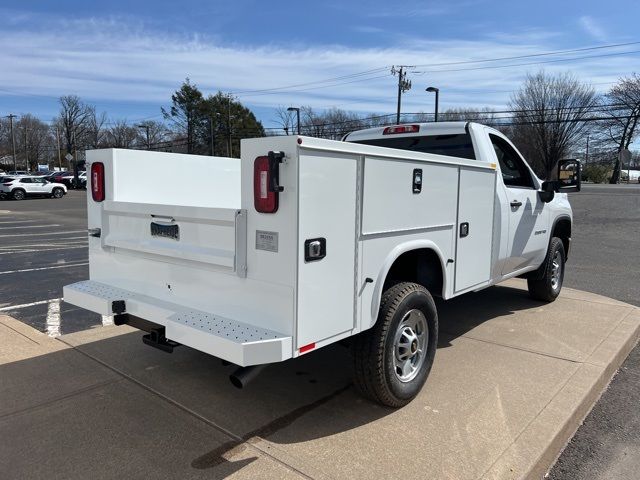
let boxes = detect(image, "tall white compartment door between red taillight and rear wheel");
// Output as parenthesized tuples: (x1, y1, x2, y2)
(296, 150, 358, 348)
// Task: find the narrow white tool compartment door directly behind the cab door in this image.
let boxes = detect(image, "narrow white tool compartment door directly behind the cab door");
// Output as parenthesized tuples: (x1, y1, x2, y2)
(455, 167, 496, 293)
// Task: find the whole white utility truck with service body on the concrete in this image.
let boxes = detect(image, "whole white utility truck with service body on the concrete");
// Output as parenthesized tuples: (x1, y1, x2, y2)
(64, 122, 580, 407)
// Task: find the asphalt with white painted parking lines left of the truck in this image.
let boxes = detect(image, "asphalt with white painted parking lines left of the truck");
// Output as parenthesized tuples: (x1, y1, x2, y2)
(0, 190, 101, 336)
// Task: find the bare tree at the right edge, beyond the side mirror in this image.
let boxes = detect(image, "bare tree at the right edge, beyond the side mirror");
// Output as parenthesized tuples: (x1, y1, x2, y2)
(599, 73, 640, 183)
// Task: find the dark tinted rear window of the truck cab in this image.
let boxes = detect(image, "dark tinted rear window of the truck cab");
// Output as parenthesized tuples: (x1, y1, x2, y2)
(354, 133, 476, 160)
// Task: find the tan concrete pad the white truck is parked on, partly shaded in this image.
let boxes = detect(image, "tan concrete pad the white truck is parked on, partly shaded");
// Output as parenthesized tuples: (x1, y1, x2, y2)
(0, 280, 640, 479)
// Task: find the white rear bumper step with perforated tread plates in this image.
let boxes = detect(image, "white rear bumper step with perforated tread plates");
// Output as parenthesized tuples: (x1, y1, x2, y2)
(64, 280, 293, 367)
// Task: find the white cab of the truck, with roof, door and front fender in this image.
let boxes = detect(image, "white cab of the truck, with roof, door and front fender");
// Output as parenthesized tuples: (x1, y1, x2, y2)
(343, 122, 575, 284)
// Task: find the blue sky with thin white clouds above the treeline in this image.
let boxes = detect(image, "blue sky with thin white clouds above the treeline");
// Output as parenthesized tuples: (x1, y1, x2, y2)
(0, 0, 640, 127)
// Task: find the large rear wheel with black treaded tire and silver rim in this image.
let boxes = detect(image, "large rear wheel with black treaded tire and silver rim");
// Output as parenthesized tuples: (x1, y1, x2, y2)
(352, 282, 438, 408)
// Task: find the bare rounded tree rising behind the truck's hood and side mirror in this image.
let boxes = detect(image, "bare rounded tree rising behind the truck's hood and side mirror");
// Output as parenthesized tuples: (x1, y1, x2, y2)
(510, 72, 597, 179)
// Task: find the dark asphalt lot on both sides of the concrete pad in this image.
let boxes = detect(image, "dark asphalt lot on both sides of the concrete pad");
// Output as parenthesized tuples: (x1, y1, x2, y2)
(0, 185, 640, 479)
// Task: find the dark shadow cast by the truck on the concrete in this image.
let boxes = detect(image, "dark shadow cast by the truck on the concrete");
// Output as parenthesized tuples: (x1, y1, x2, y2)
(0, 286, 540, 478)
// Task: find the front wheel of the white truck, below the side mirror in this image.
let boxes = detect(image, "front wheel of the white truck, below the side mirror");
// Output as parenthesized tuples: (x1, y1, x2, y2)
(527, 237, 566, 302)
